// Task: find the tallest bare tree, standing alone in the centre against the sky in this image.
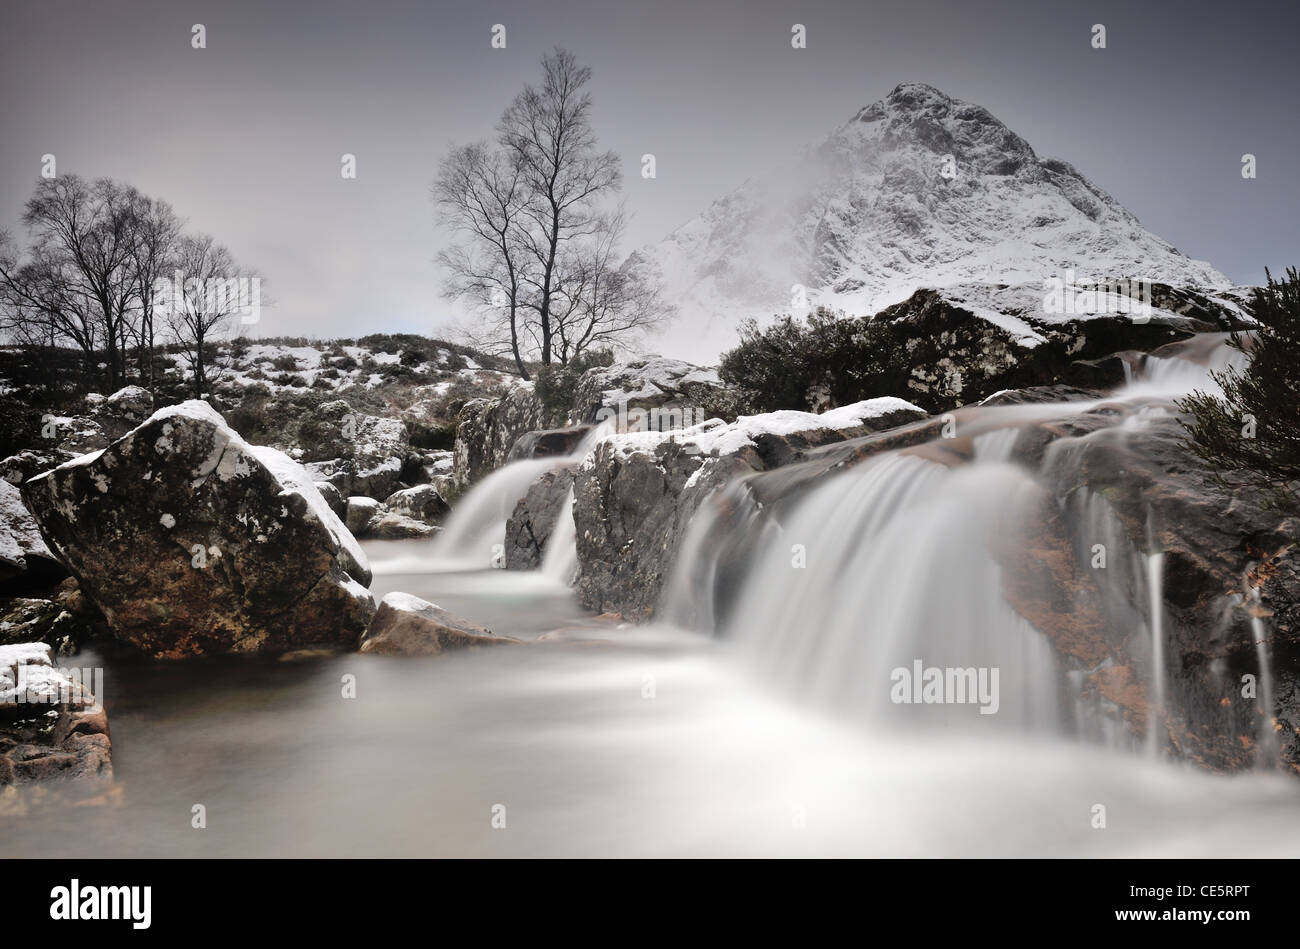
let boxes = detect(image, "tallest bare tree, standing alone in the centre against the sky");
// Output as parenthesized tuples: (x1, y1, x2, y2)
(433, 49, 666, 378)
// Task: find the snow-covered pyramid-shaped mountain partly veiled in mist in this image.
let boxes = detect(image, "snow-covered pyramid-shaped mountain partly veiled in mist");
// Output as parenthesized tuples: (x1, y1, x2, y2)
(628, 83, 1231, 361)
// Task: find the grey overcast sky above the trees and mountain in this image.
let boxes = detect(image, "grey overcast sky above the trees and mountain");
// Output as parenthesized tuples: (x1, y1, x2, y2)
(0, 0, 1300, 348)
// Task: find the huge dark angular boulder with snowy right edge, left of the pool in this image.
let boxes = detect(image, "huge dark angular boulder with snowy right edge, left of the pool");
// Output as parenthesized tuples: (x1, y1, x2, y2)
(23, 402, 374, 658)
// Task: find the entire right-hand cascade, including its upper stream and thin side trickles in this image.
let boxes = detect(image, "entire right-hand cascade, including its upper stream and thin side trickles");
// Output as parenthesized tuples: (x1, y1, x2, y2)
(659, 338, 1262, 755)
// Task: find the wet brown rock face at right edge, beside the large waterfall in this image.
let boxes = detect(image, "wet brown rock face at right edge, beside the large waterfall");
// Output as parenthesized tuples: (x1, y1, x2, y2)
(1045, 413, 1300, 772)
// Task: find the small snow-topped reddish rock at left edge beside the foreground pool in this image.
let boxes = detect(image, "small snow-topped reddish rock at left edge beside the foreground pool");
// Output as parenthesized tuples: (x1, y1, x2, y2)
(0, 642, 113, 793)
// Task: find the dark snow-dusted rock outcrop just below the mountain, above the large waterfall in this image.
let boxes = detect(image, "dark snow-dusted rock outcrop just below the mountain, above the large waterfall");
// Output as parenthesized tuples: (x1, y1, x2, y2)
(875, 285, 1244, 412)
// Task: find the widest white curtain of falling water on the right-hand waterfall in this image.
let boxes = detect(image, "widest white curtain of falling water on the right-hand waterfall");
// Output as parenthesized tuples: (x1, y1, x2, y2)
(702, 454, 1061, 731)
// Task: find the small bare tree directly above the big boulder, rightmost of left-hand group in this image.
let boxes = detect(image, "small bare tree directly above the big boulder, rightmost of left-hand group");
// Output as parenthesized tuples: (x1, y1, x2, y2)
(165, 234, 241, 399)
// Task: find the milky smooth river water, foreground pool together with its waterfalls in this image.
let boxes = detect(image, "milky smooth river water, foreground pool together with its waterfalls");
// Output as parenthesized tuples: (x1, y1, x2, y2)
(0, 328, 1300, 857)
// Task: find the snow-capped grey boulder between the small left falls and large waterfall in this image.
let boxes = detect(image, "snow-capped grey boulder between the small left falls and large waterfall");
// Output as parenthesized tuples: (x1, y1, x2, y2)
(572, 398, 926, 616)
